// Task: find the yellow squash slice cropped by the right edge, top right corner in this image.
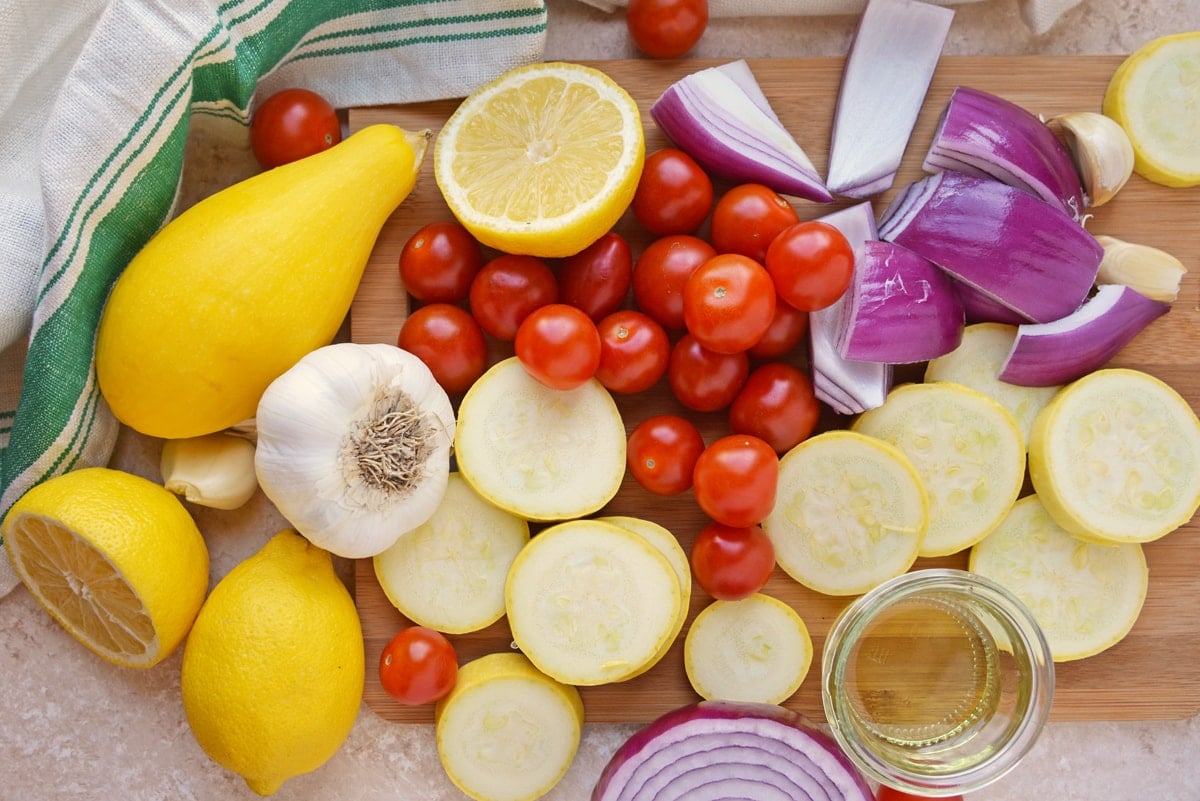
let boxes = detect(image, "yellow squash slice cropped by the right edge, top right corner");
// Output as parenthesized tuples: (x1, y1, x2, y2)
(1103, 31, 1200, 186)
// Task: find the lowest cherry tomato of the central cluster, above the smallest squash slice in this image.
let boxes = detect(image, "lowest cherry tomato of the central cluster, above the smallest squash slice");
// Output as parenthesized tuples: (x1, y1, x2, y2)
(691, 523, 775, 601)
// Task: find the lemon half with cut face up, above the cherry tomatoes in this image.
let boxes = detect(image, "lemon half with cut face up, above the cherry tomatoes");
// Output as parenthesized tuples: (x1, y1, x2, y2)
(433, 62, 646, 258)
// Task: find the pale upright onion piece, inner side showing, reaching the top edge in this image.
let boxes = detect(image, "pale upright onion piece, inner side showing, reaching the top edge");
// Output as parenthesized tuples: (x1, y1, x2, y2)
(827, 0, 954, 198)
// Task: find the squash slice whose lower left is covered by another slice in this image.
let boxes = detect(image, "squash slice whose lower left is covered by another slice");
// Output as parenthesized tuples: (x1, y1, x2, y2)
(852, 381, 1025, 556)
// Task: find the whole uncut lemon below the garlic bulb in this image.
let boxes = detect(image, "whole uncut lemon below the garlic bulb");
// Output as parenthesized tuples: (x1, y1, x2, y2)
(181, 529, 365, 795)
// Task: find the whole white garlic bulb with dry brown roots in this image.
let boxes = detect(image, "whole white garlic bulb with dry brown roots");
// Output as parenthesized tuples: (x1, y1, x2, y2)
(254, 342, 455, 559)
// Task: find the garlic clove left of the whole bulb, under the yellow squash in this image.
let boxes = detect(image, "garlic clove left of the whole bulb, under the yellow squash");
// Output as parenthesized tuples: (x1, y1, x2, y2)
(158, 432, 258, 510)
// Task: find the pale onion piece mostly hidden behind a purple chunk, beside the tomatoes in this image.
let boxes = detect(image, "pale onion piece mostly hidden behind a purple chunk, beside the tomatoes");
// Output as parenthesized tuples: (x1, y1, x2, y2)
(809, 201, 893, 415)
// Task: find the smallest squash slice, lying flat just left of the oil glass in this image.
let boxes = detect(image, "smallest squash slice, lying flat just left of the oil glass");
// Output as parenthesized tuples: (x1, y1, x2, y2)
(683, 592, 812, 704)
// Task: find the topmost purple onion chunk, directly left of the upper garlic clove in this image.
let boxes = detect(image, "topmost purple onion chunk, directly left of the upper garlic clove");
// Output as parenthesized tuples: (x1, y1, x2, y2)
(924, 86, 1086, 219)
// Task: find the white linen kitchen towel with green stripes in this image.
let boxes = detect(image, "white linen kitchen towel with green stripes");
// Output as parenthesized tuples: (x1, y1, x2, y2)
(0, 0, 546, 596)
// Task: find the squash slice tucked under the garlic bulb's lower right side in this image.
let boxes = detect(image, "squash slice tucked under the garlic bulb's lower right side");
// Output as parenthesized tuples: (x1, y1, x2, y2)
(373, 472, 529, 634)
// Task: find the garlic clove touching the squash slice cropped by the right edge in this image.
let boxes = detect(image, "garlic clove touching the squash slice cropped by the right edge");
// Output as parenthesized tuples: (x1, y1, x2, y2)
(1048, 112, 1133, 206)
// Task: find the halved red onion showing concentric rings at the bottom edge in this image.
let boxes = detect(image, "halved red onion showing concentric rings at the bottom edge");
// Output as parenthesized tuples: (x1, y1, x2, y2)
(592, 700, 875, 801)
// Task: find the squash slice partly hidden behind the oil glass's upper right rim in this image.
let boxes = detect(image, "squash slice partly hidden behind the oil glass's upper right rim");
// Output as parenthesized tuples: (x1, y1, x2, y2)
(970, 495, 1150, 662)
